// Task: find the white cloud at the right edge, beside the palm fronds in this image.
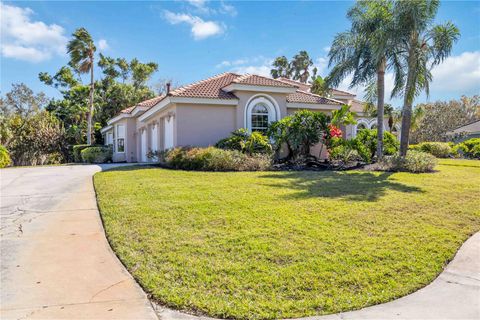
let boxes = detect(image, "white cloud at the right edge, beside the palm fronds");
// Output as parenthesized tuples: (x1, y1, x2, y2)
(430, 51, 480, 94)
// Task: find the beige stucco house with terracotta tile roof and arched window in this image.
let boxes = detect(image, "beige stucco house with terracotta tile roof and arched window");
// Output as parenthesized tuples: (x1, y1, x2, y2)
(101, 73, 394, 162)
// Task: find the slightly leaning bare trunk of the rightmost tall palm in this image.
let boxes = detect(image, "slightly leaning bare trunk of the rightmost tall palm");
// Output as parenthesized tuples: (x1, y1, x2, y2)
(400, 37, 416, 157)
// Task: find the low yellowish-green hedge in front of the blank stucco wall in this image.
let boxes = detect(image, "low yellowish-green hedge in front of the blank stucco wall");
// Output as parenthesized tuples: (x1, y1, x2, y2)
(161, 147, 271, 171)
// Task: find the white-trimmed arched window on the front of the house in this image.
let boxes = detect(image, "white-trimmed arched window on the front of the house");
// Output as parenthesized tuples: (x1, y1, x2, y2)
(245, 96, 278, 133)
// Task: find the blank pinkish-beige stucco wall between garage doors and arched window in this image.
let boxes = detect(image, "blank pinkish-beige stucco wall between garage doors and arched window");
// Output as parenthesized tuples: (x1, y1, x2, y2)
(175, 104, 238, 147)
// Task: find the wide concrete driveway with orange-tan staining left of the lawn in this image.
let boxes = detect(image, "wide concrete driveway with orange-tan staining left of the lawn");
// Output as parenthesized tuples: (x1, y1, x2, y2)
(0, 165, 157, 319)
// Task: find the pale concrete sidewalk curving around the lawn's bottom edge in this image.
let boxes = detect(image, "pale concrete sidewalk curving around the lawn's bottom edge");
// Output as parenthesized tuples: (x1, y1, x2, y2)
(156, 232, 480, 320)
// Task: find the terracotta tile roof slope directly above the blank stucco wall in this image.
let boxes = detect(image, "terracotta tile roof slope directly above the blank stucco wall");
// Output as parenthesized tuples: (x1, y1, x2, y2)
(170, 72, 240, 99)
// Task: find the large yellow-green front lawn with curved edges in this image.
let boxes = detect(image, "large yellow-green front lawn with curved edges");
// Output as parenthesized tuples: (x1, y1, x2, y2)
(95, 160, 480, 319)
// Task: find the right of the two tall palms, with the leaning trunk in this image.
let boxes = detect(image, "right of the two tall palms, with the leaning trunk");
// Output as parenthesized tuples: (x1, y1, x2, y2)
(394, 0, 460, 156)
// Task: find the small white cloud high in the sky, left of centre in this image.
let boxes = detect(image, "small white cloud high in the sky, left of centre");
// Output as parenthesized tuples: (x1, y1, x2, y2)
(164, 11, 224, 40)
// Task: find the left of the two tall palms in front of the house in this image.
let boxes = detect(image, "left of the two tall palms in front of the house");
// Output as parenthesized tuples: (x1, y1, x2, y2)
(328, 0, 404, 159)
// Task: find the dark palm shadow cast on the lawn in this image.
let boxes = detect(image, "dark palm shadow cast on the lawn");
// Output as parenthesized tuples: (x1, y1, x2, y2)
(260, 171, 424, 201)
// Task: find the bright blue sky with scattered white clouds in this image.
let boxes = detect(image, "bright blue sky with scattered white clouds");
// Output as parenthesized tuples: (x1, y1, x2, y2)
(1, 0, 480, 104)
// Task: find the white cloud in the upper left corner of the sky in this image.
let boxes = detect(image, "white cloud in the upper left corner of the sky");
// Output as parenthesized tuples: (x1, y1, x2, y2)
(0, 3, 67, 62)
